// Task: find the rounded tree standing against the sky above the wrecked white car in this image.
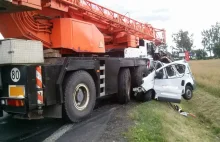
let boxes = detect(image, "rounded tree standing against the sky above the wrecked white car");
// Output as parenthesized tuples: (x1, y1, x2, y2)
(172, 30, 193, 52)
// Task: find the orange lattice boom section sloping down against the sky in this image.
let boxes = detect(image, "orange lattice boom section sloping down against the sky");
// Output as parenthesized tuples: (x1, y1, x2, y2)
(67, 0, 165, 43)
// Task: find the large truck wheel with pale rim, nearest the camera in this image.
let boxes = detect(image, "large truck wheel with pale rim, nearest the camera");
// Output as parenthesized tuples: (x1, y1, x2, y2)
(64, 71, 96, 122)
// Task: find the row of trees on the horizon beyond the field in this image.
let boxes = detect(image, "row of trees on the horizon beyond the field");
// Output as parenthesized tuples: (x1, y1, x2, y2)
(171, 22, 220, 59)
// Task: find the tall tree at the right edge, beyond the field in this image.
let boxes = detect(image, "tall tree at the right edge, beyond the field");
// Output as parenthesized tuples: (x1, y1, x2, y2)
(201, 22, 220, 56)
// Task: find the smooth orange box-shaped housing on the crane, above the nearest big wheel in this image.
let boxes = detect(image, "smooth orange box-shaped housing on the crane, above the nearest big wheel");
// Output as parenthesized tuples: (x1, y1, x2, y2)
(51, 18, 105, 53)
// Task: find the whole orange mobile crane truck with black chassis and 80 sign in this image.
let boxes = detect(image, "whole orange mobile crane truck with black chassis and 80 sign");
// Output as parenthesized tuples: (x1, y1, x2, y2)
(0, 0, 166, 122)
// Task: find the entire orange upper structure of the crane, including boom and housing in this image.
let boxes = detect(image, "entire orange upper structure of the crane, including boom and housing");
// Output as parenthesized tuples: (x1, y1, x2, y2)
(0, 0, 166, 53)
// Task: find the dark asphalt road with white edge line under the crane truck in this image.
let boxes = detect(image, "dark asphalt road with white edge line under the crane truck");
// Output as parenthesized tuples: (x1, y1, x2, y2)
(0, 97, 127, 142)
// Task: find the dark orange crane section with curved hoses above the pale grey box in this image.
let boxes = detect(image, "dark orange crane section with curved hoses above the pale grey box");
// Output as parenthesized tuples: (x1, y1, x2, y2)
(0, 12, 51, 47)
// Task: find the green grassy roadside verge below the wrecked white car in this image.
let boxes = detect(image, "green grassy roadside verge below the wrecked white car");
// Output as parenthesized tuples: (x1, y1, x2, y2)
(125, 89, 220, 142)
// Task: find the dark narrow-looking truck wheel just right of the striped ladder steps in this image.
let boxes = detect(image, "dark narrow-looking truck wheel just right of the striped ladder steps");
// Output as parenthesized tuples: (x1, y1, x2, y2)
(117, 68, 131, 104)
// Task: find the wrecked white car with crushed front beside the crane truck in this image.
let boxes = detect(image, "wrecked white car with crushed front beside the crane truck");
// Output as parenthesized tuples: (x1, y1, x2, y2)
(133, 60, 195, 103)
